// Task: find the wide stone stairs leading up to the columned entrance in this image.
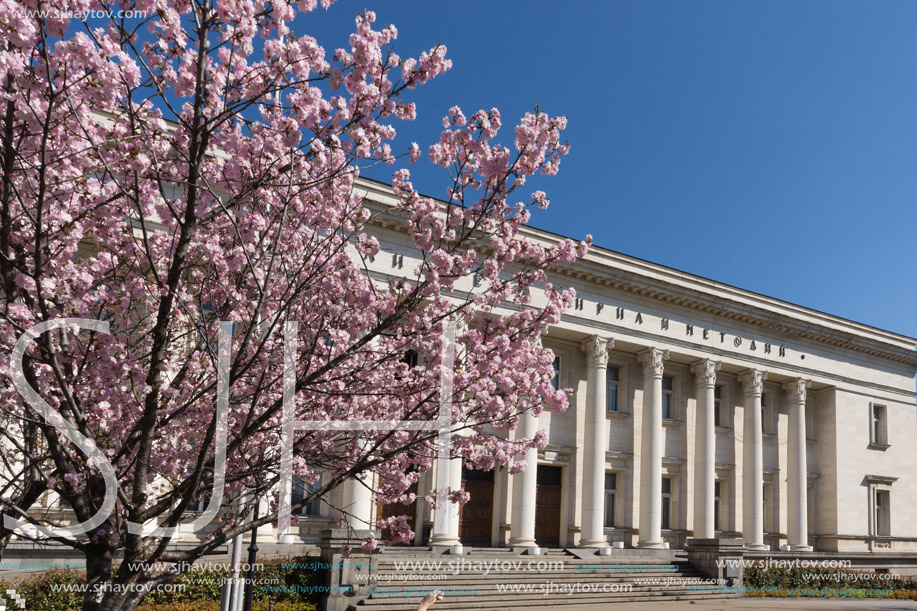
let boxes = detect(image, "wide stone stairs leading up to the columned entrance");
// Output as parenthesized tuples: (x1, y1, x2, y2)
(351, 547, 734, 611)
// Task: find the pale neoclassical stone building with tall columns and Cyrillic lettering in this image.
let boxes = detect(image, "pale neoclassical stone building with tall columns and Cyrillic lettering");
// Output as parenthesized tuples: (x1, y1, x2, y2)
(314, 182, 917, 552)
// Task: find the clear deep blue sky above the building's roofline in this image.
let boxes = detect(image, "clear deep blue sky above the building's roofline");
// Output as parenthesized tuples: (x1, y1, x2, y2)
(296, 0, 917, 336)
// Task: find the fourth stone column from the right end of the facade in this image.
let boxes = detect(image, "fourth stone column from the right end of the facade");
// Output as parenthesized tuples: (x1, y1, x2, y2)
(637, 348, 669, 548)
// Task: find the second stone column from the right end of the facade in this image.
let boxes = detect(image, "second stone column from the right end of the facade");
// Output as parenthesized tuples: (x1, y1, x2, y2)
(739, 369, 767, 549)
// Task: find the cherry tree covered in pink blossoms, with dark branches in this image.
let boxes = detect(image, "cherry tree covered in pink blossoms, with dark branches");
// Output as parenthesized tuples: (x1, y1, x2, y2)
(0, 0, 588, 611)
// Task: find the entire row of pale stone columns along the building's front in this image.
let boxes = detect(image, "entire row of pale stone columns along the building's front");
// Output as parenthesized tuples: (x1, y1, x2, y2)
(336, 336, 812, 551)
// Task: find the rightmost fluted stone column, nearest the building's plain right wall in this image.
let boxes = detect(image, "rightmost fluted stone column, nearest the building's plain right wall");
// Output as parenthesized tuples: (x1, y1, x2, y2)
(783, 378, 812, 552)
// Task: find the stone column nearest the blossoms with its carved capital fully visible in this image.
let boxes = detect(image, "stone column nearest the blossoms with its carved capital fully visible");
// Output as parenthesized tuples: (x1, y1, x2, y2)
(580, 335, 614, 547)
